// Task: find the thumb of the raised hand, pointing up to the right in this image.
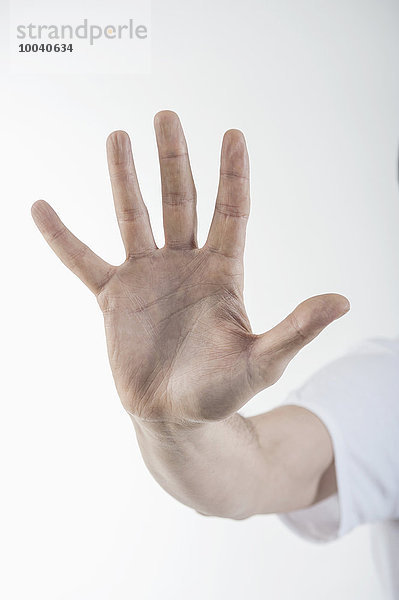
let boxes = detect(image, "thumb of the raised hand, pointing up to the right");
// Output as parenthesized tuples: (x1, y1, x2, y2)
(249, 294, 350, 393)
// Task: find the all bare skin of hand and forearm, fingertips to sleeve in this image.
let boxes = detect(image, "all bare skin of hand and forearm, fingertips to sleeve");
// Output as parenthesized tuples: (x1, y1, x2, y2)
(32, 111, 349, 519)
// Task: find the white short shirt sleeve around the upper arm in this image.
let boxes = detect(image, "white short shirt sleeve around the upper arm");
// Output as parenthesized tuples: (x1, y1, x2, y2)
(279, 339, 399, 542)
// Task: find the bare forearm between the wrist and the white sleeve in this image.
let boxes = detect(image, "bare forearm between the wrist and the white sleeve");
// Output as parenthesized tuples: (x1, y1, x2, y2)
(133, 406, 338, 519)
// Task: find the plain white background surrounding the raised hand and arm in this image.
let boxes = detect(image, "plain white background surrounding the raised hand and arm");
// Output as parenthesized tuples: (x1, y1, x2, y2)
(0, 0, 399, 600)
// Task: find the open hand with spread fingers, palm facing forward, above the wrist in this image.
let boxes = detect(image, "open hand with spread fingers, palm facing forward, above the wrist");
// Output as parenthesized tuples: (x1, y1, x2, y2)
(32, 111, 349, 423)
